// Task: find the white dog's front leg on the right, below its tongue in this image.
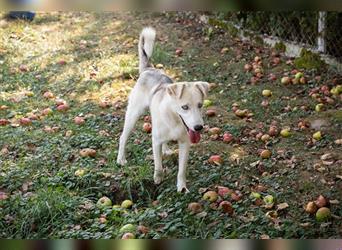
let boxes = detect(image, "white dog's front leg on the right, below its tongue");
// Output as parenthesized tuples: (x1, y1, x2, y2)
(177, 142, 190, 193)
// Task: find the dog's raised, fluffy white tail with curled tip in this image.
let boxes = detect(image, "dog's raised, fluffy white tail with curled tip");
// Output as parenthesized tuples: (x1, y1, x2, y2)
(138, 27, 156, 73)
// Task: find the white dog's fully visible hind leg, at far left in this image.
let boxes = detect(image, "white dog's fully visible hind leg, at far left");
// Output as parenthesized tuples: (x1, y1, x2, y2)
(116, 91, 148, 165)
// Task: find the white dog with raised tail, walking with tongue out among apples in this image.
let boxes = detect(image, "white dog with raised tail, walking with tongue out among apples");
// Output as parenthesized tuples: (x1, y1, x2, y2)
(117, 27, 209, 192)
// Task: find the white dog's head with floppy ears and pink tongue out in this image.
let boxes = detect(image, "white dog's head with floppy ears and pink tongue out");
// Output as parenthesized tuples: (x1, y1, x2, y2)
(167, 82, 209, 143)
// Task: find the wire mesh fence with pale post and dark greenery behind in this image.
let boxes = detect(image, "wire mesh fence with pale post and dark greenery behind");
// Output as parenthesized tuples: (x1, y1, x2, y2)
(213, 11, 342, 62)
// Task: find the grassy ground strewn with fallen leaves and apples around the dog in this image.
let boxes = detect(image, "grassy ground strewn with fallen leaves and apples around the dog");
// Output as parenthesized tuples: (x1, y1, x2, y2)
(0, 13, 342, 239)
